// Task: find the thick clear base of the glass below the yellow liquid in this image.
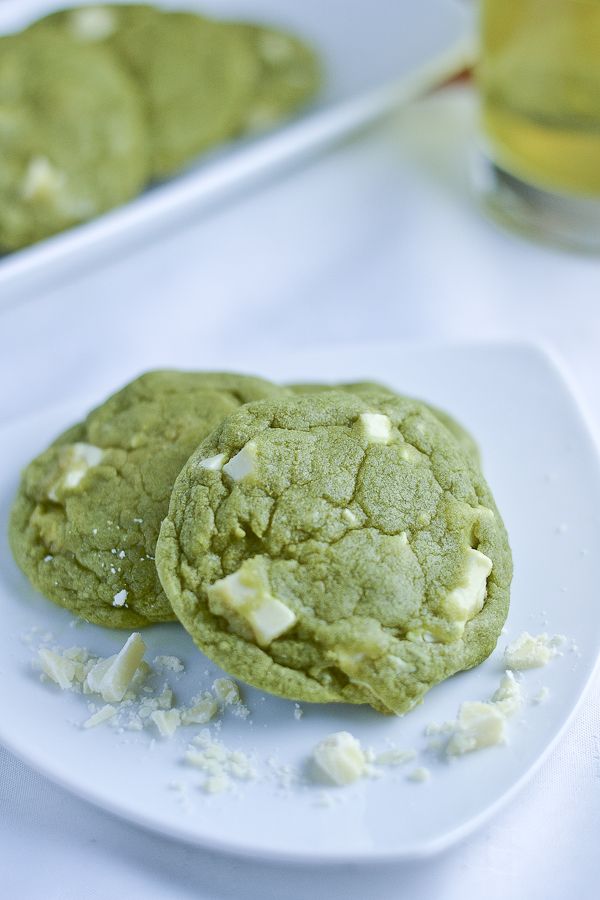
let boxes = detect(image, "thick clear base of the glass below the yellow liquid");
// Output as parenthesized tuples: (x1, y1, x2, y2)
(473, 151, 600, 253)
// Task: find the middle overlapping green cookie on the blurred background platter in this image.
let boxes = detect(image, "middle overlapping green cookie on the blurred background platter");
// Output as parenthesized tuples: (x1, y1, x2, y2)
(33, 5, 259, 178)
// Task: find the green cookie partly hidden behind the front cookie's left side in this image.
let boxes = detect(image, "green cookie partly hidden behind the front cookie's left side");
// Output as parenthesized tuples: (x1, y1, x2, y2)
(10, 371, 283, 628)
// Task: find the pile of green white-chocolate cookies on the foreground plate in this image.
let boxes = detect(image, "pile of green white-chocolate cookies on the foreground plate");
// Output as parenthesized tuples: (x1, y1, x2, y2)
(10, 371, 512, 713)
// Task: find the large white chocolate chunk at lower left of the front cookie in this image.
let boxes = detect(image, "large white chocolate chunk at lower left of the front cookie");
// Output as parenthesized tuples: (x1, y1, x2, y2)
(207, 560, 297, 647)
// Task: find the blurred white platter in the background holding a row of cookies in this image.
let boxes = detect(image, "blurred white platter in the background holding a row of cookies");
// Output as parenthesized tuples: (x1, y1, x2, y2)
(0, 0, 473, 296)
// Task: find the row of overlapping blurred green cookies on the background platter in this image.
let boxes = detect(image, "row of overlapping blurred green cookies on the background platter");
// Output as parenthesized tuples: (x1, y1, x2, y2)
(0, 4, 320, 250)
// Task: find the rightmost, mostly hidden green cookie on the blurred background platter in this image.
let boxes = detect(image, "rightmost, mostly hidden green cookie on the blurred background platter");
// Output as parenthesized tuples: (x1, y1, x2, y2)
(238, 24, 322, 131)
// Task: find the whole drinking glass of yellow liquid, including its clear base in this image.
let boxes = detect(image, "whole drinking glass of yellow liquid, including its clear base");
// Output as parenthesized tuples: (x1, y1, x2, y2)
(476, 0, 600, 251)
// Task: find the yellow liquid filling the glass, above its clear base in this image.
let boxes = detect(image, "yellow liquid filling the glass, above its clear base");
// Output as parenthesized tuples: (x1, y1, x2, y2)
(477, 0, 600, 197)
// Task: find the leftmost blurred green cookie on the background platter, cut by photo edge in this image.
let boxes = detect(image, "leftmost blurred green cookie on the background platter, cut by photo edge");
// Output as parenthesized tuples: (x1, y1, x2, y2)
(0, 31, 149, 250)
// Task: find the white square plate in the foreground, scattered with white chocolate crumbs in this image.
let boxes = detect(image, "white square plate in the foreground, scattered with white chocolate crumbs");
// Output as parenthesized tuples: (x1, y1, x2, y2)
(0, 344, 600, 862)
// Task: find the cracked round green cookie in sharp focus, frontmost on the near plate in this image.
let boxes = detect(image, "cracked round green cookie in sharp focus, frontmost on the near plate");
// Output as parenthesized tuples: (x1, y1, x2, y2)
(156, 391, 512, 714)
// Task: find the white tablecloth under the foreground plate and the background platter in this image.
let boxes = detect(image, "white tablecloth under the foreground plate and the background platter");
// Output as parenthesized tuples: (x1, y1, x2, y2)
(0, 82, 600, 900)
